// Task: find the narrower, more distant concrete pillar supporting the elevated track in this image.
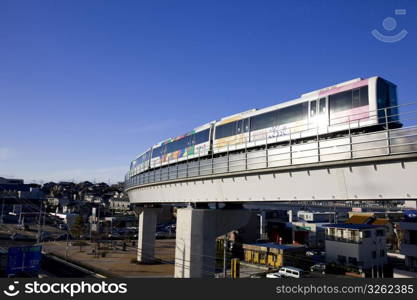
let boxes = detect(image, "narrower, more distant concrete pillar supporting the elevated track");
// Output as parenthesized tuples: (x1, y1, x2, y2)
(137, 207, 160, 263)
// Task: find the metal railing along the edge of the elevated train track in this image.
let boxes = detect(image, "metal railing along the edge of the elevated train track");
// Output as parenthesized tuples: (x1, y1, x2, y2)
(125, 102, 417, 189)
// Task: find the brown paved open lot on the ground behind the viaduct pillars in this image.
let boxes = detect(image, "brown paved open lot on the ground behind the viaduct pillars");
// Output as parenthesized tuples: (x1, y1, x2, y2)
(43, 239, 175, 277)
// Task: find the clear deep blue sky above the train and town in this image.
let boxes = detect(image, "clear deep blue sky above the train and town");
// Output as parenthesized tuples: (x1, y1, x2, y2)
(0, 0, 417, 182)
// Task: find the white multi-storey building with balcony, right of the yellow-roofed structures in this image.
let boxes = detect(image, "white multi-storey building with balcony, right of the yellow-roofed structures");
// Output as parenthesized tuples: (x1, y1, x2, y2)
(324, 224, 387, 274)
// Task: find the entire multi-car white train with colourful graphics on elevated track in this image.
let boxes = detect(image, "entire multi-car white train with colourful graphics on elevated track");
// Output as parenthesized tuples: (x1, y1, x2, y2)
(126, 76, 401, 179)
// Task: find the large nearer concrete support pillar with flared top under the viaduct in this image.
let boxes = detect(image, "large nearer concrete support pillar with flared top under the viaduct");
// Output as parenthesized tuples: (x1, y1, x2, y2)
(175, 207, 252, 278)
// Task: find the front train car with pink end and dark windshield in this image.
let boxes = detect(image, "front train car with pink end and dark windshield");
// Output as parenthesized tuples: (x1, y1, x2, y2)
(213, 77, 398, 153)
